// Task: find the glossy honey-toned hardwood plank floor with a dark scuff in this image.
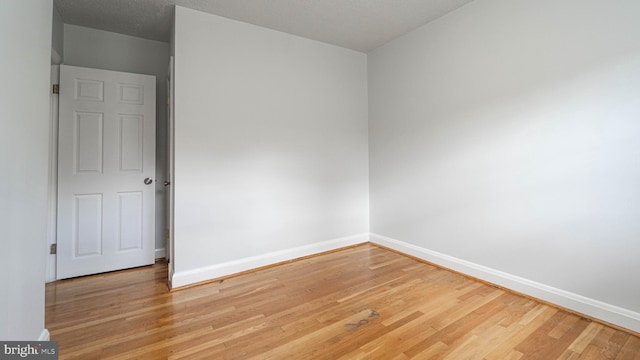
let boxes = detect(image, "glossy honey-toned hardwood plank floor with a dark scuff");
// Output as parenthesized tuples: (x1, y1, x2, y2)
(46, 244, 640, 360)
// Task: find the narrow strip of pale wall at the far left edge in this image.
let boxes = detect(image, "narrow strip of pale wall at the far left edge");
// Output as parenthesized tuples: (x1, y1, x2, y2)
(0, 0, 53, 341)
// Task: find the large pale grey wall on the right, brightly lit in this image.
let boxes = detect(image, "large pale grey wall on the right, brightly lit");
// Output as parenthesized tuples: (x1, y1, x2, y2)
(368, 0, 640, 318)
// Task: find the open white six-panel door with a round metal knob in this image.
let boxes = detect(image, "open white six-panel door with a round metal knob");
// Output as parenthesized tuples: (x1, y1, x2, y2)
(56, 65, 156, 279)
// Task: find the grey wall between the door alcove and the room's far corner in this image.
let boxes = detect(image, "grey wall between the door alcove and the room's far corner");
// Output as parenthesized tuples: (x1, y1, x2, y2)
(174, 7, 368, 282)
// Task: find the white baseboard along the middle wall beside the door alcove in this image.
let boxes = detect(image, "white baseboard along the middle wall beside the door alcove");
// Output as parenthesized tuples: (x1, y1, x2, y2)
(171, 233, 369, 288)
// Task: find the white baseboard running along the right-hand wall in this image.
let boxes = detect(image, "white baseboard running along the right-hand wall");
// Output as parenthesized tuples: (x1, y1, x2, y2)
(370, 233, 640, 332)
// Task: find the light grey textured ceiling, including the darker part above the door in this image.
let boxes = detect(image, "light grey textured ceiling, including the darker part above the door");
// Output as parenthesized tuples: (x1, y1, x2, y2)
(54, 0, 472, 52)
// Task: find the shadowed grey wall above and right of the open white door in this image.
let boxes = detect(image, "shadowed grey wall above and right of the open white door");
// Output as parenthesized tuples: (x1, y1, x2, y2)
(64, 24, 169, 256)
